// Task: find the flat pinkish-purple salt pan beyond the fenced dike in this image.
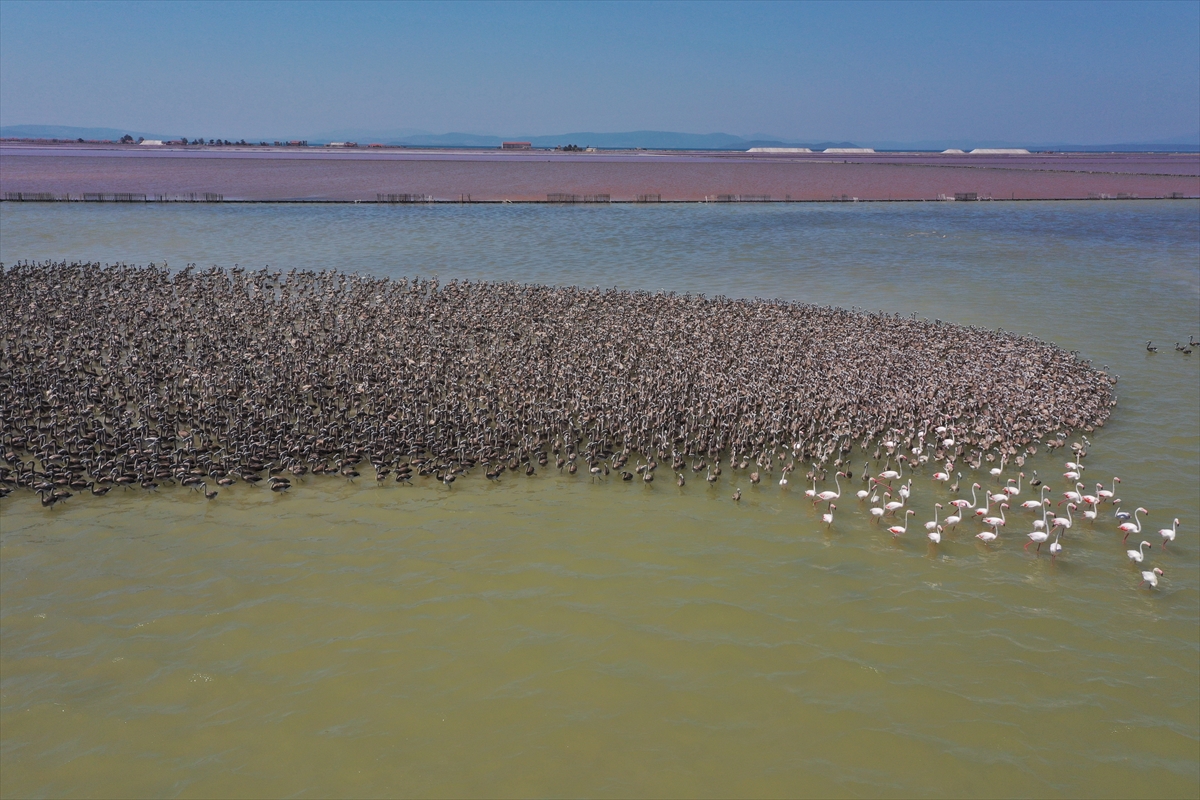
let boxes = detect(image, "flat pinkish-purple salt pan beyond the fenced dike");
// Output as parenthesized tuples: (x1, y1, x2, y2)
(0, 144, 1200, 203)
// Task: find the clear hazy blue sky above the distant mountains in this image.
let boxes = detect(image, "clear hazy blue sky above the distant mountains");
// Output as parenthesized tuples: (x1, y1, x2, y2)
(0, 0, 1200, 144)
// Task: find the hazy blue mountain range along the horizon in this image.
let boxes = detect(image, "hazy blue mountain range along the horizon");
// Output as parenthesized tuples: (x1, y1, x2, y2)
(0, 125, 1200, 152)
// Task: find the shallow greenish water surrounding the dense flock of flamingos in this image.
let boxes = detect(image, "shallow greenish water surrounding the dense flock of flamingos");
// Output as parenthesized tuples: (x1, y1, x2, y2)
(0, 201, 1200, 796)
